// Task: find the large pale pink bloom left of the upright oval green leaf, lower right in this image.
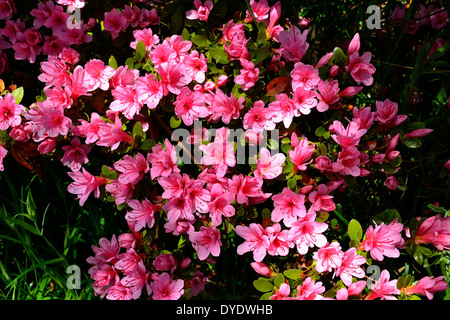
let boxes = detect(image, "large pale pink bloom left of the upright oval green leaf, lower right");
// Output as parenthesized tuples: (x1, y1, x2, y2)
(289, 212, 328, 255)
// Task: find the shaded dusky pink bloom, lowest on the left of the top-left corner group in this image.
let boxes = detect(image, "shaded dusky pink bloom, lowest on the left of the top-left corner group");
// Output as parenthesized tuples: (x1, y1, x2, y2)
(12, 28, 42, 63)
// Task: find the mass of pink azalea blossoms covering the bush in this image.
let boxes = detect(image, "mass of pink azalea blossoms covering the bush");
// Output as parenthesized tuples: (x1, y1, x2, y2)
(0, 0, 450, 300)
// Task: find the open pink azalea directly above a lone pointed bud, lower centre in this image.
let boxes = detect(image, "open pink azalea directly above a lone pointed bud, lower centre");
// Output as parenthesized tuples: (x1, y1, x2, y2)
(236, 223, 270, 262)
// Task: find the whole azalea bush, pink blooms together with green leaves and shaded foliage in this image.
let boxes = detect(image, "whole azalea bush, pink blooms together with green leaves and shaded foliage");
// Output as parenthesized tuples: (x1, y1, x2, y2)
(0, 0, 450, 300)
